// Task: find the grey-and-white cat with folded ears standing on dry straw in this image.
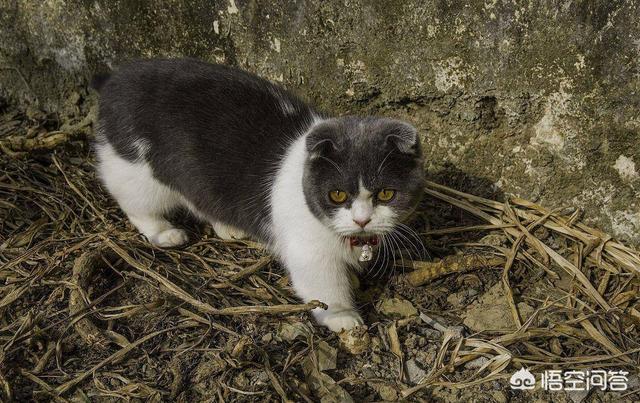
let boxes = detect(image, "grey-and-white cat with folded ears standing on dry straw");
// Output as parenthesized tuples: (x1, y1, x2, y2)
(94, 59, 424, 332)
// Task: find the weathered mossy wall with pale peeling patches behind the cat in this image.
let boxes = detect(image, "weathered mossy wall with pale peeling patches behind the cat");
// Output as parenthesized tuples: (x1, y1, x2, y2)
(0, 0, 640, 243)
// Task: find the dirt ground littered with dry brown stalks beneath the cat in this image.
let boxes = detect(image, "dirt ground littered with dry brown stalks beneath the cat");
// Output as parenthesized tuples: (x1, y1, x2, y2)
(0, 105, 640, 402)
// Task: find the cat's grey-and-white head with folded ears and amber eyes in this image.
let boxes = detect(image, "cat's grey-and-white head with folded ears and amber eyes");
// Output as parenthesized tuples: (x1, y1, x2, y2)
(303, 117, 424, 238)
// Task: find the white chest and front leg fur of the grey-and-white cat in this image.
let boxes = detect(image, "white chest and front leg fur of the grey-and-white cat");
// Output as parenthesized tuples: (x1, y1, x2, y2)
(271, 129, 363, 331)
